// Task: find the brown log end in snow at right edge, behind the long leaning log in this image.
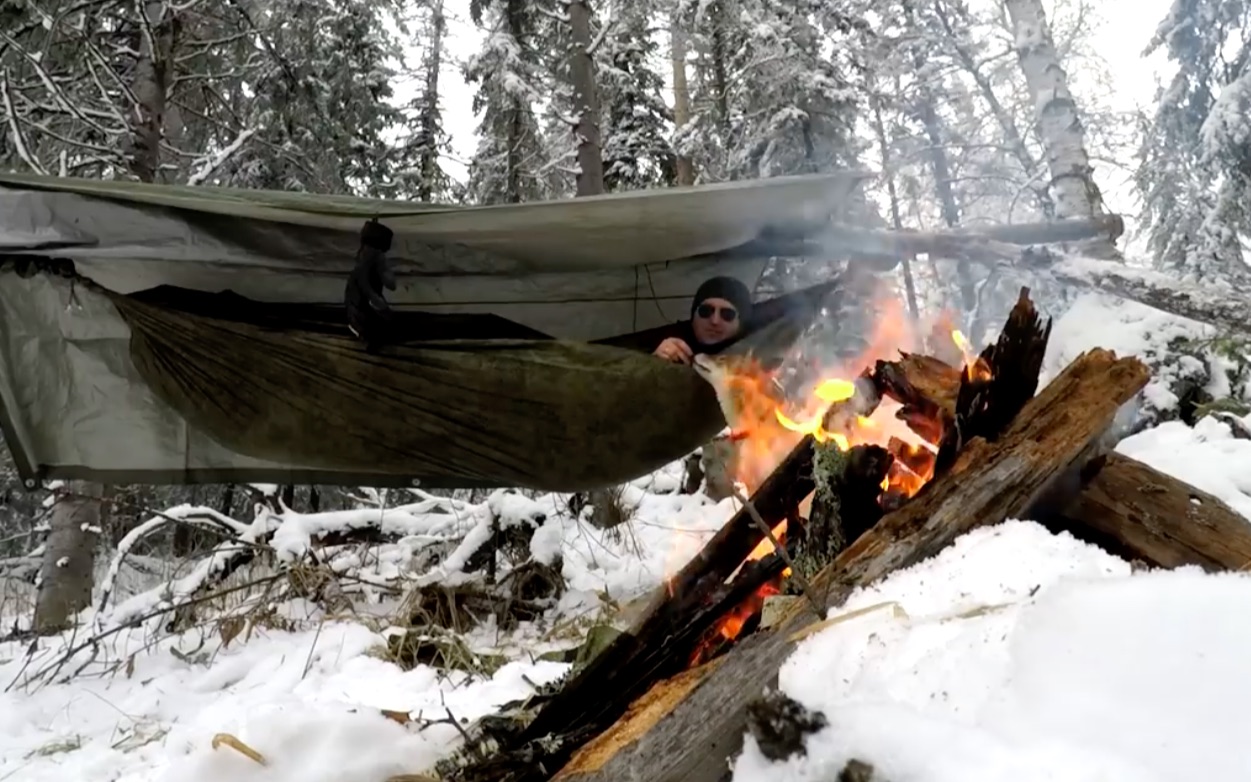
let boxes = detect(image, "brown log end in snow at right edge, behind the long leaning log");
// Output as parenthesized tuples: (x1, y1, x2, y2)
(1040, 453, 1251, 572)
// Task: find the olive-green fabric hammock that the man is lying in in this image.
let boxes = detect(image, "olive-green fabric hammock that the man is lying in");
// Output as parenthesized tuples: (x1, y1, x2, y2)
(102, 284, 832, 492)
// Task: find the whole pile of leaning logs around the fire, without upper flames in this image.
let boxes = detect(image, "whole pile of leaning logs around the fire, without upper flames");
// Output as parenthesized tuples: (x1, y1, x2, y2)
(438, 289, 1251, 782)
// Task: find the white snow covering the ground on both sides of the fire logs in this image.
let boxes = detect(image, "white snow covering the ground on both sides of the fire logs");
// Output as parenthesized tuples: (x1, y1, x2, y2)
(0, 290, 1251, 782)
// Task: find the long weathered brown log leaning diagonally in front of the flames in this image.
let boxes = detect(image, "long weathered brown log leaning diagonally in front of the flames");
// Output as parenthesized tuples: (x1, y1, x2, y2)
(554, 350, 1150, 782)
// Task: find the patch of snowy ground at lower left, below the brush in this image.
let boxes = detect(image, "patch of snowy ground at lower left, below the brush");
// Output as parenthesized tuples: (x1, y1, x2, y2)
(0, 615, 567, 782)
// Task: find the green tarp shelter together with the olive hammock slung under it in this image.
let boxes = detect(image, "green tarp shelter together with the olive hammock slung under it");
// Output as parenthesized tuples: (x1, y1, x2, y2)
(0, 175, 857, 490)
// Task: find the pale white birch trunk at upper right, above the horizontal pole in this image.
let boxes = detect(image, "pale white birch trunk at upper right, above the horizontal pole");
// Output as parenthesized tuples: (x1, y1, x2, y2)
(1003, 0, 1103, 228)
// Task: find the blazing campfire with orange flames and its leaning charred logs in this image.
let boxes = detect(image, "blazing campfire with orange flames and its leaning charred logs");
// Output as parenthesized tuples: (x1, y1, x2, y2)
(439, 289, 1175, 782)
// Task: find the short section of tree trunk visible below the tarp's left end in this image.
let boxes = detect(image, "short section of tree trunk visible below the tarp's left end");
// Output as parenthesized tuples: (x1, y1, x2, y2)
(34, 480, 100, 634)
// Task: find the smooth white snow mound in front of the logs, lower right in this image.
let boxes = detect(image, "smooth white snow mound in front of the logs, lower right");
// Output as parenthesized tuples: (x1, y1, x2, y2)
(734, 522, 1251, 782)
